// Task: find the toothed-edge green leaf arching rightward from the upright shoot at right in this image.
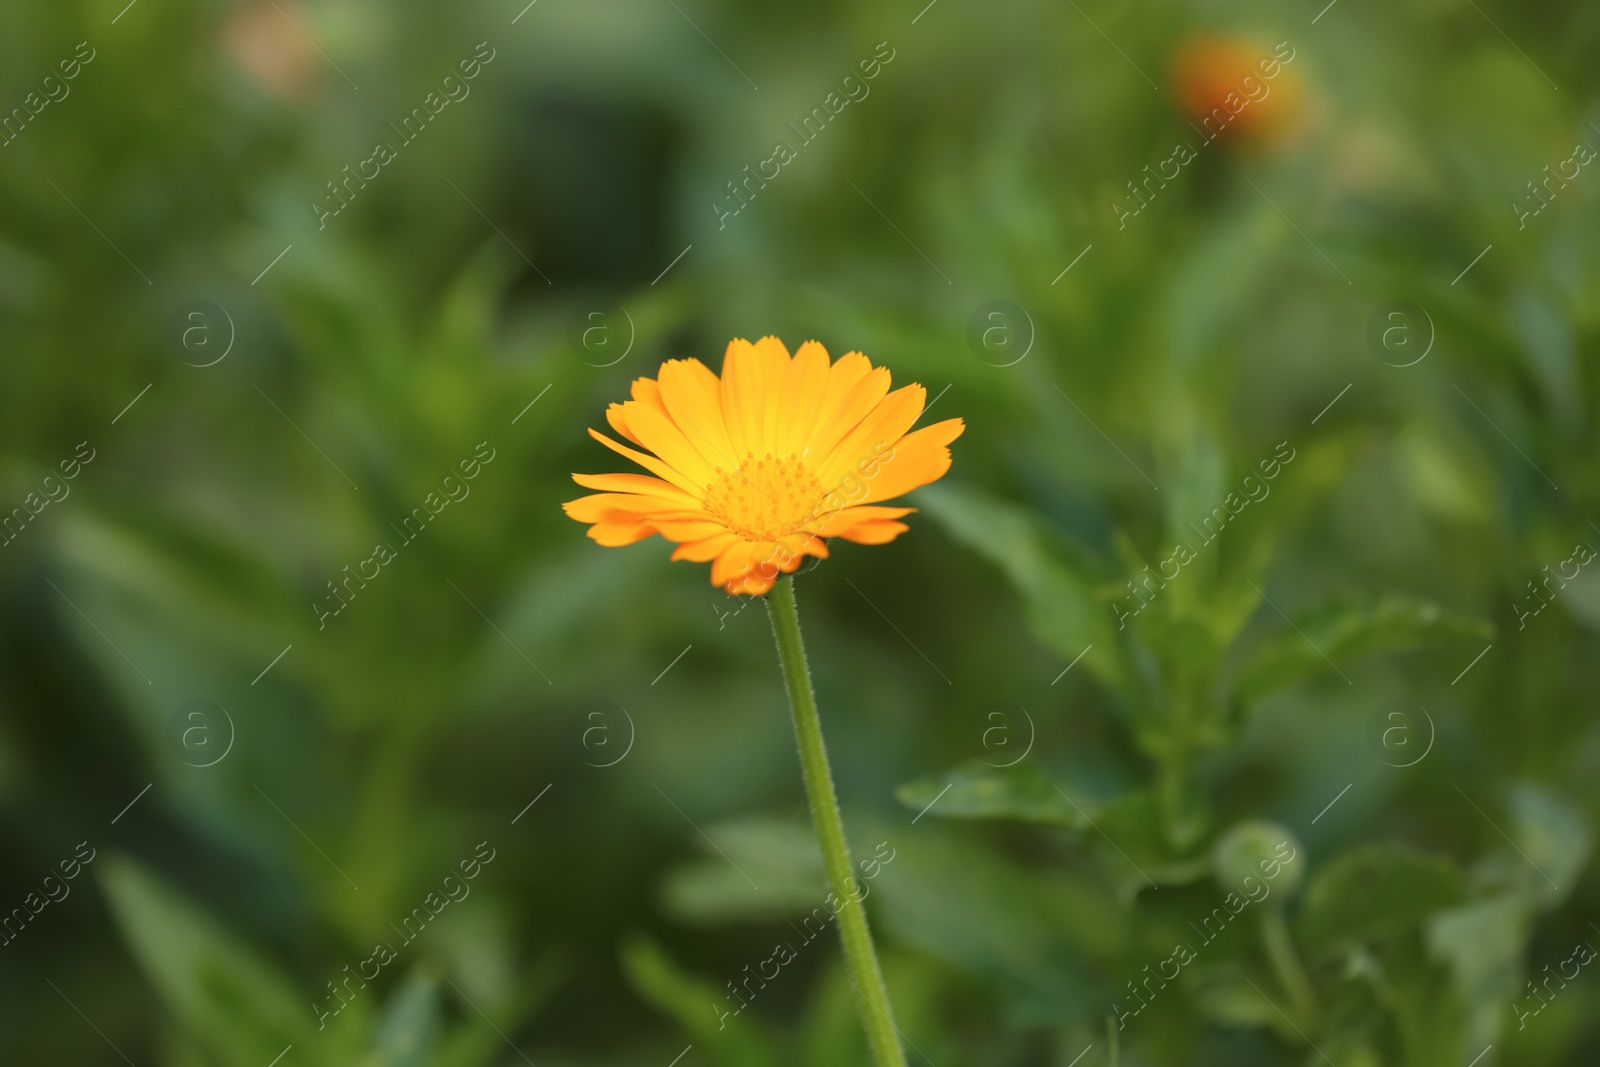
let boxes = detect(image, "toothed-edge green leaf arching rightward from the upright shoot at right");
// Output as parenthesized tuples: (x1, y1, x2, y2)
(1234, 593, 1494, 707)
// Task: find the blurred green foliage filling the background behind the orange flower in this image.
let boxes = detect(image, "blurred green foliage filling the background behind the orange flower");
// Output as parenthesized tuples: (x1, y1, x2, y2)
(0, 0, 1600, 1067)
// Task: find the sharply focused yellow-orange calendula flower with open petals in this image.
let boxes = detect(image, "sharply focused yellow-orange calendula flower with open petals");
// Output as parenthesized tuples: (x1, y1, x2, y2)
(563, 338, 965, 595)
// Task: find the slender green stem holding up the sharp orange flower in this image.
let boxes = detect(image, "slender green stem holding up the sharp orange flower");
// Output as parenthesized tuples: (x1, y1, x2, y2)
(766, 574, 906, 1067)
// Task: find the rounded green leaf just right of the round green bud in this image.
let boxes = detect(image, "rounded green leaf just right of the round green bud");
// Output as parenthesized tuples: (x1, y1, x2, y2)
(1299, 843, 1464, 955)
